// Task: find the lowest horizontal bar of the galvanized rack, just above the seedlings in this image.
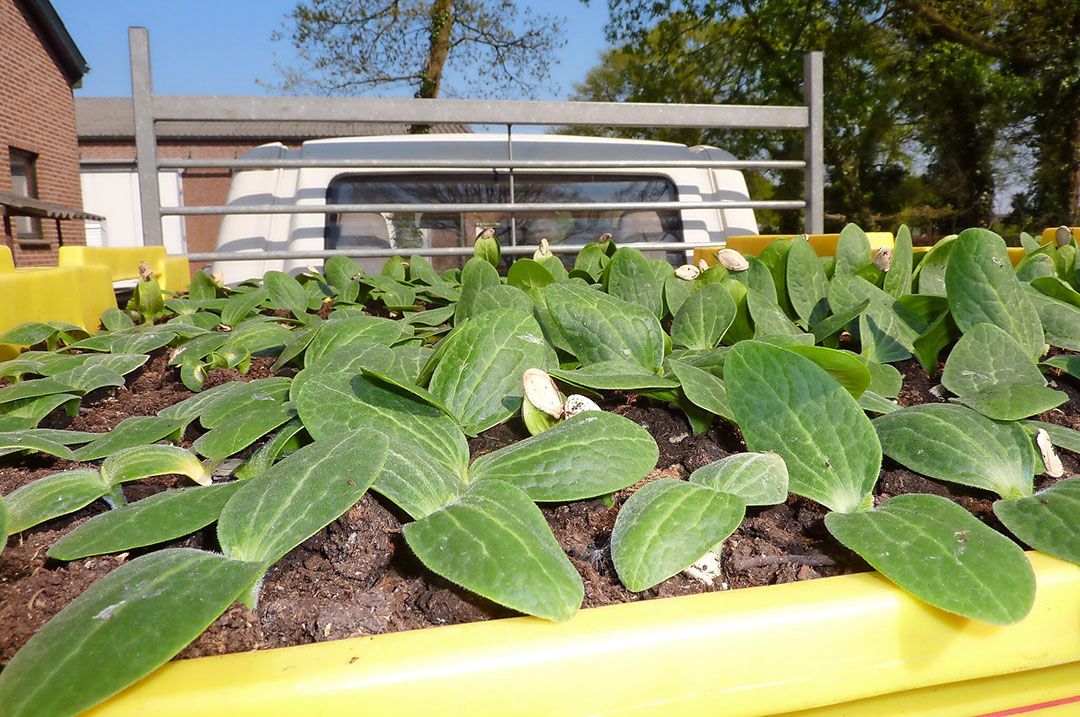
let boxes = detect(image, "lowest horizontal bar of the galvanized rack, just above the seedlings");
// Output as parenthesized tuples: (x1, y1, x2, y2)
(187, 242, 725, 261)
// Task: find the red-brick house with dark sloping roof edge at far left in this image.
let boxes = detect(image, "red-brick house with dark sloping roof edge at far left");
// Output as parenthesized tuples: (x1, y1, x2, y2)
(0, 0, 94, 266)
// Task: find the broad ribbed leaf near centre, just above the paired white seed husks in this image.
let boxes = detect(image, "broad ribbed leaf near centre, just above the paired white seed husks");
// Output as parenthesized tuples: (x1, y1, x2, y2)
(544, 284, 664, 373)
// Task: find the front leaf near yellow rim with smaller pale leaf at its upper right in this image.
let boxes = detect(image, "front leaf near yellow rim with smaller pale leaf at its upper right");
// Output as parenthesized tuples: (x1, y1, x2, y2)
(611, 478, 746, 593)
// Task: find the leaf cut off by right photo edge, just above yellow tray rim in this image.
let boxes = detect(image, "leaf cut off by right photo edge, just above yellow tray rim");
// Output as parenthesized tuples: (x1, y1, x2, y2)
(994, 478, 1080, 565)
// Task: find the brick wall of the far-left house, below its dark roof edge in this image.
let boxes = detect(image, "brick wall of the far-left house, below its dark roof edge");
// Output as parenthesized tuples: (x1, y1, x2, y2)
(0, 0, 85, 267)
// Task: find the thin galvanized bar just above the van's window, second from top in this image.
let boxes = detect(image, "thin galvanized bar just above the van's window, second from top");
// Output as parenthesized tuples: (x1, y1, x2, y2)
(156, 158, 807, 170)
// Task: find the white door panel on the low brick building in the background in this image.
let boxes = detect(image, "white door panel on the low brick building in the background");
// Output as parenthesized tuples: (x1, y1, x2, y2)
(80, 167, 187, 254)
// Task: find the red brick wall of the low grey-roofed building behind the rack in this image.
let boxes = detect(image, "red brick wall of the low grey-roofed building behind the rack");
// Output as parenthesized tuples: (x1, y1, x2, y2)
(79, 138, 289, 263)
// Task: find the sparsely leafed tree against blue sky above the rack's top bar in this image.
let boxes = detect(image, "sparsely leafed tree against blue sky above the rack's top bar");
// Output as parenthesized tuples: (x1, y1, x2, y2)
(274, 0, 562, 98)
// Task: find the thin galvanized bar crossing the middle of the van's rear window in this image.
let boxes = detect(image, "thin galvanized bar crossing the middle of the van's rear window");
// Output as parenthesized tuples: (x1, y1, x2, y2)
(161, 200, 806, 216)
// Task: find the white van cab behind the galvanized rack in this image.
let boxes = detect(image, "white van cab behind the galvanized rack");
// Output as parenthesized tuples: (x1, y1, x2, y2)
(213, 134, 757, 283)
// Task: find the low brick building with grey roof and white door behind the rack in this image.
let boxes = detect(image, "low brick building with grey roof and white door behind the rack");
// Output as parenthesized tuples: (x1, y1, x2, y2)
(75, 97, 468, 262)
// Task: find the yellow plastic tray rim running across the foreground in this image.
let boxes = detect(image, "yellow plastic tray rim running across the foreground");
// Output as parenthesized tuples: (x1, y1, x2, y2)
(89, 553, 1080, 717)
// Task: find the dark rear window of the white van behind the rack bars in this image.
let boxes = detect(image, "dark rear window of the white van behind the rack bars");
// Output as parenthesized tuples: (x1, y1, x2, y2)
(325, 172, 683, 262)
